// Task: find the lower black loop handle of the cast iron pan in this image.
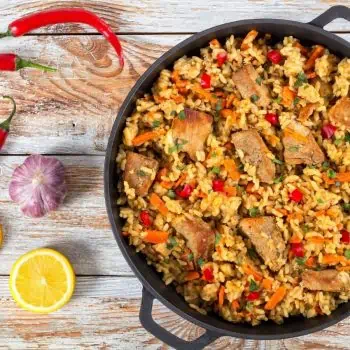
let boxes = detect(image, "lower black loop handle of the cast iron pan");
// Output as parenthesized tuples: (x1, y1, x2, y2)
(140, 288, 221, 350)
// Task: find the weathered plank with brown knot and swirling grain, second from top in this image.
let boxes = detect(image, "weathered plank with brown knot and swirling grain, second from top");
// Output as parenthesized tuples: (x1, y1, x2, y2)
(0, 34, 350, 154)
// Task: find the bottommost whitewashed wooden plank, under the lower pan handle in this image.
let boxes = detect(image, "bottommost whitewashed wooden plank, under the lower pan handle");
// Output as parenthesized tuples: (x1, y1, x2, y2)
(0, 277, 350, 350)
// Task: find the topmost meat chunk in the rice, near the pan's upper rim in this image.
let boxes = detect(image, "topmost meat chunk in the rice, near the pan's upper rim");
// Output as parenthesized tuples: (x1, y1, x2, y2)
(232, 64, 271, 107)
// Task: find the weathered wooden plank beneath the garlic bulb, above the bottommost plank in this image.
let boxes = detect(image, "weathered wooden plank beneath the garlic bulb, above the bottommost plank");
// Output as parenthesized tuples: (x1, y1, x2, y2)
(0, 156, 132, 275)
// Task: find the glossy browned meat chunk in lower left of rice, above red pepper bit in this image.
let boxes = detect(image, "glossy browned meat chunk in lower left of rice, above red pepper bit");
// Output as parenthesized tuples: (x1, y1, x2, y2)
(172, 215, 215, 263)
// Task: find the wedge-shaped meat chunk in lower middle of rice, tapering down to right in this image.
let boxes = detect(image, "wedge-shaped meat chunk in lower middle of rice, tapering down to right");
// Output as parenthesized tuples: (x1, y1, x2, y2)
(239, 216, 286, 271)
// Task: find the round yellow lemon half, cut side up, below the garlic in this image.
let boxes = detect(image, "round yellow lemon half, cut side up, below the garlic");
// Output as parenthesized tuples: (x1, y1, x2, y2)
(9, 248, 75, 314)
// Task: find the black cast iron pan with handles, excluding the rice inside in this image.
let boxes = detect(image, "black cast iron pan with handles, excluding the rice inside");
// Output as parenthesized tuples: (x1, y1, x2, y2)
(104, 6, 350, 350)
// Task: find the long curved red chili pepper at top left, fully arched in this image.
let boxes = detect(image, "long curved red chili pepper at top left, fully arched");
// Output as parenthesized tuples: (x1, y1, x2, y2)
(0, 8, 124, 68)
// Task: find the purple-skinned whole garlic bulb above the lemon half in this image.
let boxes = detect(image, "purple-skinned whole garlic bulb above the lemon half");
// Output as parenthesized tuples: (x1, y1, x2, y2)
(9, 154, 67, 218)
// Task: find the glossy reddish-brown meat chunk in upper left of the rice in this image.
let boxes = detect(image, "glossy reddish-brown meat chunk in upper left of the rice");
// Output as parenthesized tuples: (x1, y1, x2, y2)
(172, 108, 213, 160)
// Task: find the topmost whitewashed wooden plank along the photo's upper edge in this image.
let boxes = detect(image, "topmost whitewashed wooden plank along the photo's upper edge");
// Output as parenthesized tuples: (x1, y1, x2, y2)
(0, 0, 350, 33)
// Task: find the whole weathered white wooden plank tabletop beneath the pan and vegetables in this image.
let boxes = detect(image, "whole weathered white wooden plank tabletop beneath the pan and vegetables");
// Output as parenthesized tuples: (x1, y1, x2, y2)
(0, 0, 350, 350)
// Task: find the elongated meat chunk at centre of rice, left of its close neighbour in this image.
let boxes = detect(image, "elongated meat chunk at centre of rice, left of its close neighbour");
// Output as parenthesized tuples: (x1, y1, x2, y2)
(232, 130, 276, 183)
